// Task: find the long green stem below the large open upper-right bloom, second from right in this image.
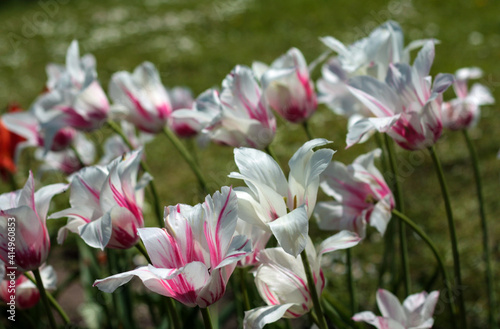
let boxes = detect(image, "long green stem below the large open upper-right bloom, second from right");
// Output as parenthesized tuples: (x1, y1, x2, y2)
(429, 146, 467, 329)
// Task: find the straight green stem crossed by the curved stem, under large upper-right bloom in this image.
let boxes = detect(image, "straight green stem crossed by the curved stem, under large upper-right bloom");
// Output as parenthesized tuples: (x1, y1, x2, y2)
(384, 134, 411, 296)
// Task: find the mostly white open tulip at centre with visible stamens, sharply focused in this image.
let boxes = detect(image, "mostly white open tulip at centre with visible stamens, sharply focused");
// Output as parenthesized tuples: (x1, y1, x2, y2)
(229, 138, 335, 257)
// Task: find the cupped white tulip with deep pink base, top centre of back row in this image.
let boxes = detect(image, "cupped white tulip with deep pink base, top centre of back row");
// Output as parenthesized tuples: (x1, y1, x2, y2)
(261, 48, 318, 123)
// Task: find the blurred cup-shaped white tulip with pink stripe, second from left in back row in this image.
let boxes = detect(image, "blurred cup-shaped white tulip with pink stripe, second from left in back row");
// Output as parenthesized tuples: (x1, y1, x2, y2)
(109, 62, 172, 133)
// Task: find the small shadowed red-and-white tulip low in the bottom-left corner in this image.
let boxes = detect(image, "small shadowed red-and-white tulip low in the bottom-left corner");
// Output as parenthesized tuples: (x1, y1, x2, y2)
(0, 266, 57, 309)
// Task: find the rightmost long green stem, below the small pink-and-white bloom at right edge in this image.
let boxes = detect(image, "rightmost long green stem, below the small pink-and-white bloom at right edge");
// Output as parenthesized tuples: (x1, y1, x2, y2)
(462, 129, 498, 329)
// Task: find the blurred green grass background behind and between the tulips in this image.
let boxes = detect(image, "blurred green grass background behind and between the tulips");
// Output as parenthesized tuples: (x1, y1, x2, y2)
(0, 0, 500, 328)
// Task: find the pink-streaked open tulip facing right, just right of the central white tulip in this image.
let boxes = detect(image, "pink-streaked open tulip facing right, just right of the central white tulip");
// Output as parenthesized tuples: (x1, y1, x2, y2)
(315, 149, 394, 238)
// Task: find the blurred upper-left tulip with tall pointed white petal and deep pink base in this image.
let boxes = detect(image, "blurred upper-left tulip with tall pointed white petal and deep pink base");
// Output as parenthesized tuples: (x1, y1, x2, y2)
(31, 41, 109, 151)
